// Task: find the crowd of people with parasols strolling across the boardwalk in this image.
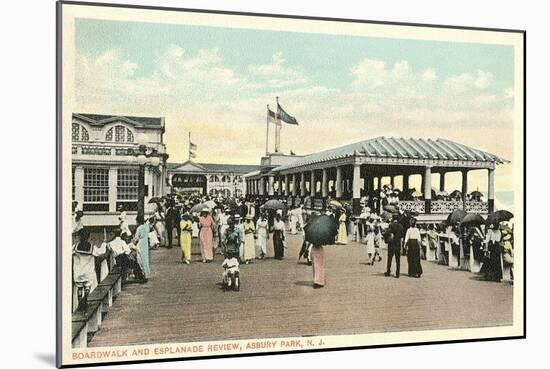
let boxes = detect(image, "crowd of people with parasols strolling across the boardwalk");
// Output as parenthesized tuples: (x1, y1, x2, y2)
(73, 190, 513, 305)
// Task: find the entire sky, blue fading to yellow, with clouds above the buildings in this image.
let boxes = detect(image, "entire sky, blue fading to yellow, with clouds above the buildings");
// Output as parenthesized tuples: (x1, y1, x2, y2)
(75, 19, 514, 198)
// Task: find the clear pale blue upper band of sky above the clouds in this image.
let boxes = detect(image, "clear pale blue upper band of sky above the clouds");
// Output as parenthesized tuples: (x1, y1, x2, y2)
(76, 19, 513, 91)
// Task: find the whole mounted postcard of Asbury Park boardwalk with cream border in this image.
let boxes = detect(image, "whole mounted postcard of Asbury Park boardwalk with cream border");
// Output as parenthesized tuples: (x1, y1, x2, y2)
(57, 2, 525, 366)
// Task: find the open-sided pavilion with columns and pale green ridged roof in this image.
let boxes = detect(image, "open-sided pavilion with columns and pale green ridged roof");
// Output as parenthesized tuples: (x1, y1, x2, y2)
(246, 137, 509, 214)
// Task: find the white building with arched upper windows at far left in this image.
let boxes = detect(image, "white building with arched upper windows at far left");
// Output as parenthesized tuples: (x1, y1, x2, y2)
(72, 113, 168, 226)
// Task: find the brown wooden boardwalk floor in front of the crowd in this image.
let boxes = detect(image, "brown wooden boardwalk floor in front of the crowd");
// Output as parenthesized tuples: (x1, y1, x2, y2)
(90, 231, 513, 347)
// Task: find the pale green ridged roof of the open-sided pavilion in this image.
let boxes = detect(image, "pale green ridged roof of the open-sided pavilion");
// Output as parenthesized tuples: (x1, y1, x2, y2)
(273, 137, 509, 172)
